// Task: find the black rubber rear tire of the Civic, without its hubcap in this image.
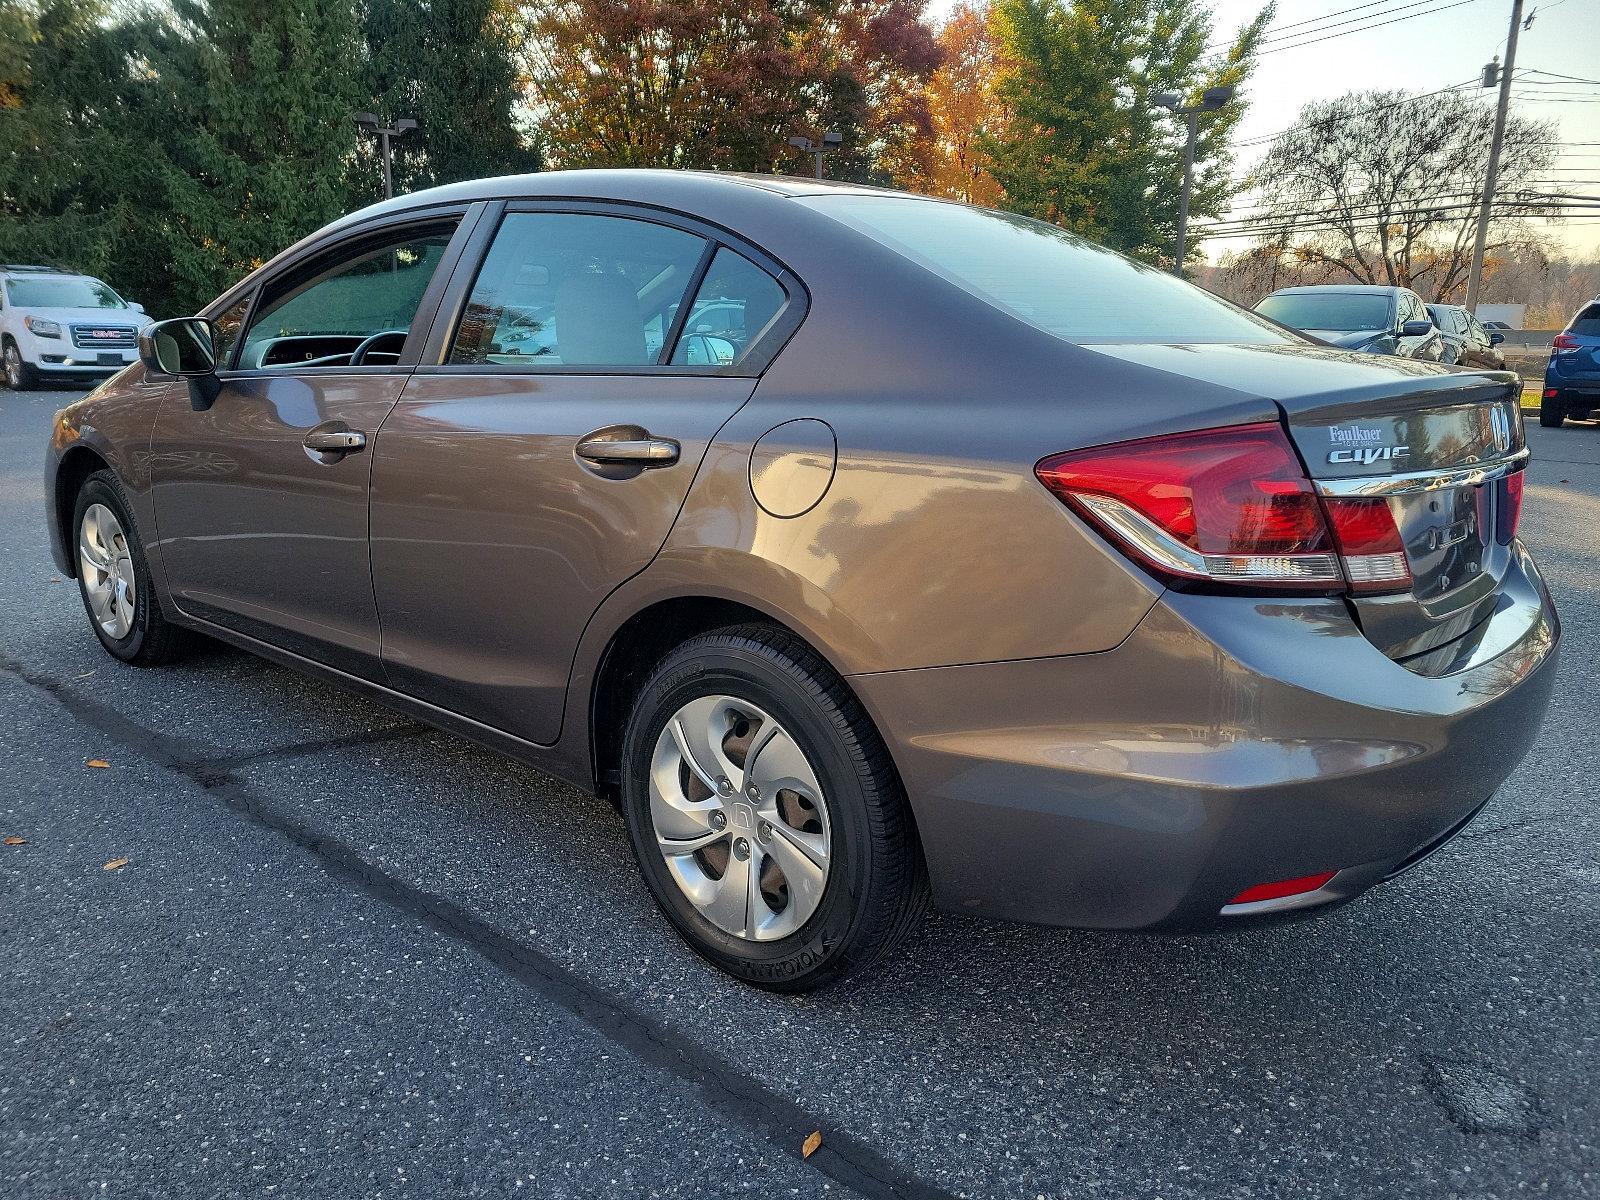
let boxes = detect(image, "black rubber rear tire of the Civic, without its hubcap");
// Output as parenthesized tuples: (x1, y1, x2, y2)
(622, 624, 928, 992)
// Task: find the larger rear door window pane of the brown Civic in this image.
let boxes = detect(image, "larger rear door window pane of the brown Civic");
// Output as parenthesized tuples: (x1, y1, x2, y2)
(450, 213, 706, 366)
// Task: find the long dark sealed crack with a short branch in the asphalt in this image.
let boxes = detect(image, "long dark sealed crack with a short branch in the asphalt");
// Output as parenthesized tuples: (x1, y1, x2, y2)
(0, 654, 954, 1200)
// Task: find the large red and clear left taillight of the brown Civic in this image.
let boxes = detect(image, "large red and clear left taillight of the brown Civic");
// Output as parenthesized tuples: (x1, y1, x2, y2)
(1034, 422, 1411, 592)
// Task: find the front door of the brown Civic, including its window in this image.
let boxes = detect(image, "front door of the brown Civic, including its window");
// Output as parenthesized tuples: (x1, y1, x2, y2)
(150, 211, 464, 678)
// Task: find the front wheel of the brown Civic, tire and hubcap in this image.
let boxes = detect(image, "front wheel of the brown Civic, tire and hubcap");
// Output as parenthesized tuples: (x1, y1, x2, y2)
(72, 470, 192, 667)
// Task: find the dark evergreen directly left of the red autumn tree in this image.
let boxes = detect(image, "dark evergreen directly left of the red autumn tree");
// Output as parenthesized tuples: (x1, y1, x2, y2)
(363, 0, 539, 192)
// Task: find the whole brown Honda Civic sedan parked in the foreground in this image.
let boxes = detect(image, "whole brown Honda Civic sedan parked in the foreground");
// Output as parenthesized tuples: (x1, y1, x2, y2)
(46, 171, 1558, 990)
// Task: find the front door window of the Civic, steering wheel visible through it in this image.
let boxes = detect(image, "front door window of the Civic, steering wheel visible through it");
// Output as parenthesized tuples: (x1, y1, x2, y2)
(238, 229, 453, 370)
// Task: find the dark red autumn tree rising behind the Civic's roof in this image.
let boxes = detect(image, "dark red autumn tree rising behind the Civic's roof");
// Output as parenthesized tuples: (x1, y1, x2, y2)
(531, 0, 938, 178)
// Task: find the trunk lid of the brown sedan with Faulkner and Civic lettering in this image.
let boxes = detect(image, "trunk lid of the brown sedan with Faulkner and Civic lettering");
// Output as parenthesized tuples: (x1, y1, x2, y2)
(1094, 346, 1528, 666)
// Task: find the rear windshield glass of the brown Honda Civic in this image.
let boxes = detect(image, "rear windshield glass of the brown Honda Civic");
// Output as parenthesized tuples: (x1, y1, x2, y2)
(803, 195, 1290, 342)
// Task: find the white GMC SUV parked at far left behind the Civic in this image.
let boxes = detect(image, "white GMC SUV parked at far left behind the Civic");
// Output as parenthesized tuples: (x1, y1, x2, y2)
(0, 264, 146, 390)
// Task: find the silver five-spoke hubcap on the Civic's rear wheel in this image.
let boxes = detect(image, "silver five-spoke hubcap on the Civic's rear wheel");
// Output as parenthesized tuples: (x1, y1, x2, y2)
(650, 696, 832, 942)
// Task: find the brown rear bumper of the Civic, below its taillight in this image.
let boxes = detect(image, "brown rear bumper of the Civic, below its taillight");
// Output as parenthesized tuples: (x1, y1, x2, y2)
(851, 552, 1560, 930)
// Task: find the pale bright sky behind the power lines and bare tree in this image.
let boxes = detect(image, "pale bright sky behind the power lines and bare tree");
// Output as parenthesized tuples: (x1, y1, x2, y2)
(930, 0, 1600, 259)
